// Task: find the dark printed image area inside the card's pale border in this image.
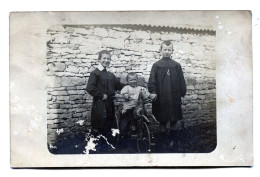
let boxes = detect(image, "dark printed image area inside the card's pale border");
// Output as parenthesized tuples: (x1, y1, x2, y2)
(46, 24, 217, 154)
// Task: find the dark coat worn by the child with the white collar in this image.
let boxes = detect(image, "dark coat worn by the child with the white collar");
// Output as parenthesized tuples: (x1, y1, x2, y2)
(87, 69, 123, 129)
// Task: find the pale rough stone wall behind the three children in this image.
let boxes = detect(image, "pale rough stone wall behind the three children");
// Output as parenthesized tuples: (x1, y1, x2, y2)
(46, 25, 216, 147)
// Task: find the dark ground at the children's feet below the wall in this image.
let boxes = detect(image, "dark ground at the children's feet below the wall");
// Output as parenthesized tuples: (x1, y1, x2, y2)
(48, 123, 217, 154)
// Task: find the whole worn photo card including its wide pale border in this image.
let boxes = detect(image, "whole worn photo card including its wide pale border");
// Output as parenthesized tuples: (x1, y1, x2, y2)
(10, 11, 253, 167)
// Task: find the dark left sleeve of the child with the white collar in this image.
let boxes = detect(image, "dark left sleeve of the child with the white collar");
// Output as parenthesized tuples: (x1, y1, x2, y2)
(87, 72, 103, 99)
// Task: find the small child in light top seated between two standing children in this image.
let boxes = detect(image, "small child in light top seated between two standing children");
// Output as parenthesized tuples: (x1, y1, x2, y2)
(120, 72, 150, 138)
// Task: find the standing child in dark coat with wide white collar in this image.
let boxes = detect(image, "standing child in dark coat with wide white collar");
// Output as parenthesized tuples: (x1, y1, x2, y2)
(87, 50, 124, 147)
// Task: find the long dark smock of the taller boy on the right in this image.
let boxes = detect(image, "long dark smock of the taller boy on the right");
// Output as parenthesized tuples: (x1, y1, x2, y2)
(148, 58, 186, 123)
